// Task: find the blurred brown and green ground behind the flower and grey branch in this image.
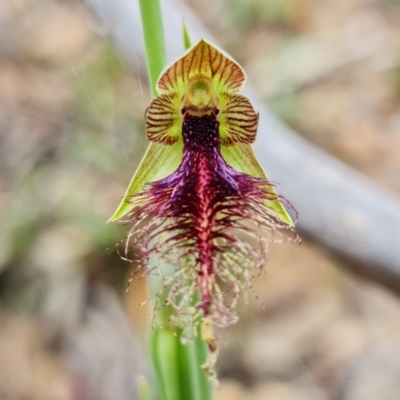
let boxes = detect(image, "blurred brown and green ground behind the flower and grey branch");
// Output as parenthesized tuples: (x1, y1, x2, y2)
(0, 0, 400, 400)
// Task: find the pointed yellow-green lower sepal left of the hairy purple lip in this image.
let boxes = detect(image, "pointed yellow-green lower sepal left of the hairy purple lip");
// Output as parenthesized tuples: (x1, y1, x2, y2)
(108, 142, 182, 222)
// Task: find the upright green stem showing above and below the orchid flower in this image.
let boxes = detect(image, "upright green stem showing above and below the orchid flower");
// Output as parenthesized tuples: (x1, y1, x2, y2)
(139, 0, 212, 400)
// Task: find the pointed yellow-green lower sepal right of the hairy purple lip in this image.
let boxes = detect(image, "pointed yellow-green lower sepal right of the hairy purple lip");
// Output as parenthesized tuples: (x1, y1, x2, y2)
(221, 144, 294, 226)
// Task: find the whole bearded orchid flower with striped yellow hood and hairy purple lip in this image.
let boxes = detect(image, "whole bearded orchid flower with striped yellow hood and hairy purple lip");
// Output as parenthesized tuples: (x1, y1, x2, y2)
(110, 40, 298, 364)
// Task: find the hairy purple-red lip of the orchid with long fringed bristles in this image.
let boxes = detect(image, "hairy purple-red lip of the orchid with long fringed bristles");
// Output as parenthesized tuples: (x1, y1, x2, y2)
(122, 114, 296, 326)
